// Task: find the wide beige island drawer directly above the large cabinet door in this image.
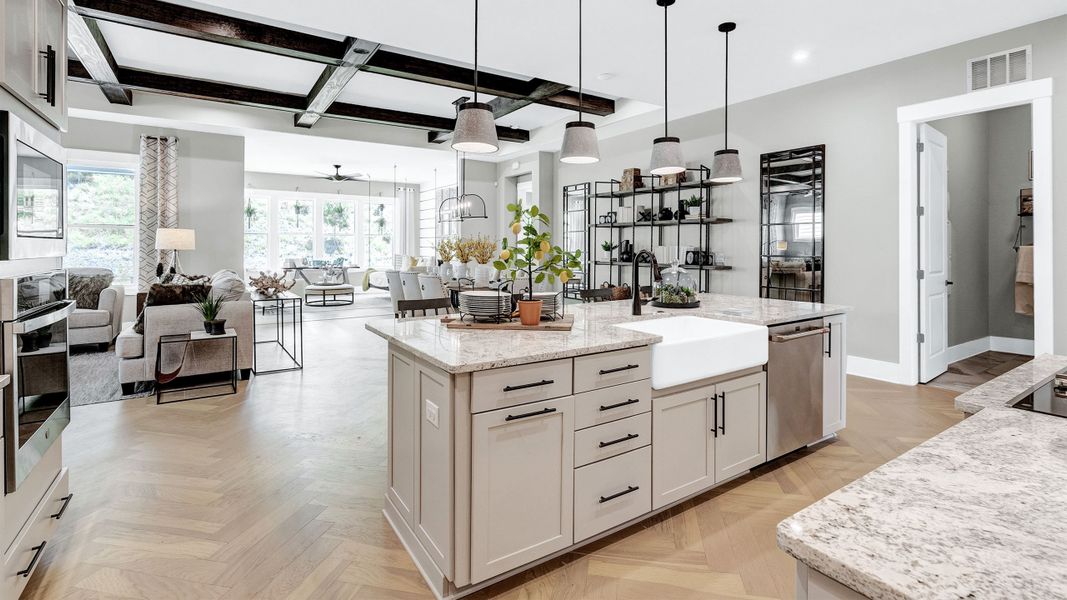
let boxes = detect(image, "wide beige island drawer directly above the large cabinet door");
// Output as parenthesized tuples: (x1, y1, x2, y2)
(471, 359, 573, 412)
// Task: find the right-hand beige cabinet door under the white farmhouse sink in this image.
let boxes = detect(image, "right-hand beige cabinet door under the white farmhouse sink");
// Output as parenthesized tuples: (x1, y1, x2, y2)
(712, 373, 767, 483)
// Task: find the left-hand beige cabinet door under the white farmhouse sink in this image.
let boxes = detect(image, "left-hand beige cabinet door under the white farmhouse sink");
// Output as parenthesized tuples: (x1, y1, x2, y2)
(652, 386, 715, 508)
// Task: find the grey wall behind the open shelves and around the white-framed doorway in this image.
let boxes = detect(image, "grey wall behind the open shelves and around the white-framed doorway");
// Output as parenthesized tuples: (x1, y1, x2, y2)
(556, 17, 1067, 363)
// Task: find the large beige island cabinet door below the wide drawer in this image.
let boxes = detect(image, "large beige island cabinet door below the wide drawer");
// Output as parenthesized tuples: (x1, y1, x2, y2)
(471, 396, 574, 583)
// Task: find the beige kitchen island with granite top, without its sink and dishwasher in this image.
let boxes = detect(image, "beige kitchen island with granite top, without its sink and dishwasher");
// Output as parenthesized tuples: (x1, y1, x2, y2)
(367, 295, 847, 598)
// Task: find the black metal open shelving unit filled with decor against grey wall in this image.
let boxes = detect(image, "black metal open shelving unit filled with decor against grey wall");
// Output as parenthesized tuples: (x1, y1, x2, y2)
(580, 164, 733, 291)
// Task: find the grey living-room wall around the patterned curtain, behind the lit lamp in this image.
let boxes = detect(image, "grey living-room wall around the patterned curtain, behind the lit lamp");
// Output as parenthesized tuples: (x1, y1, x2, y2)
(63, 119, 244, 273)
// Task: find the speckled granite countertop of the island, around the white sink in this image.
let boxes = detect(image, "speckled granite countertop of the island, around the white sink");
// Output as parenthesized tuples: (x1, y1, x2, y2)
(366, 294, 848, 373)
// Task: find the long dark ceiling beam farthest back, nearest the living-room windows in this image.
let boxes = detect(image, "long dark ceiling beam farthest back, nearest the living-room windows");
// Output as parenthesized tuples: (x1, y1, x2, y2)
(67, 60, 530, 142)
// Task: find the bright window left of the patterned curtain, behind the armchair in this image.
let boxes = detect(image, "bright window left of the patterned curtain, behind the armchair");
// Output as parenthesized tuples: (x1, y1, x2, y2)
(65, 167, 138, 286)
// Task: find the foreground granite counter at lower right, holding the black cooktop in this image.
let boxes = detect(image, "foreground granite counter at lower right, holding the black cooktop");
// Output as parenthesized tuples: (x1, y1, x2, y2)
(778, 356, 1067, 599)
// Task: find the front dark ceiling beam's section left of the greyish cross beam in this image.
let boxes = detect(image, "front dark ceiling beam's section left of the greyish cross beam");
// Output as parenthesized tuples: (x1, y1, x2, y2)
(75, 0, 345, 66)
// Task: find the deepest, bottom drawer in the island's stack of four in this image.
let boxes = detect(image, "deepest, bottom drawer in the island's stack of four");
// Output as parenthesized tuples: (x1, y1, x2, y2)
(574, 446, 652, 542)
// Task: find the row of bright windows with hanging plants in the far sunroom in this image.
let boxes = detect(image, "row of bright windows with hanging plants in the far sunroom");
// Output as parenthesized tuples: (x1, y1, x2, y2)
(244, 190, 397, 272)
